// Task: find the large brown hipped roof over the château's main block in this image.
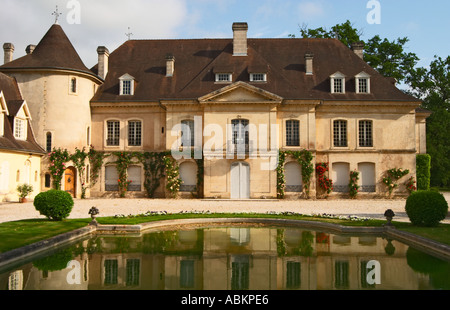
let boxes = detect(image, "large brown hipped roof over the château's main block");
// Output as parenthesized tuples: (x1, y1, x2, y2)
(92, 38, 418, 102)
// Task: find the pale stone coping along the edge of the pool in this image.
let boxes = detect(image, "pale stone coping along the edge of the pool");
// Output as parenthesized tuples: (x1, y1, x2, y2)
(0, 218, 450, 269)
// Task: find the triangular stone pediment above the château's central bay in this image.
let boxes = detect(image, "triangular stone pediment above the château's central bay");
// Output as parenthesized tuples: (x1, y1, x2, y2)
(198, 82, 283, 104)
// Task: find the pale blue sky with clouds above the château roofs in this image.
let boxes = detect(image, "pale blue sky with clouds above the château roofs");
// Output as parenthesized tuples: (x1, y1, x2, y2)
(0, 0, 450, 67)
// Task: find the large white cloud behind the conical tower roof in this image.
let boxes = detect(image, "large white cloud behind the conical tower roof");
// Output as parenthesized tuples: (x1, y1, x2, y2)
(0, 0, 188, 67)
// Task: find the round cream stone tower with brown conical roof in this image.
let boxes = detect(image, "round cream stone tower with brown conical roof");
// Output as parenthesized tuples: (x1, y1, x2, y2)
(0, 24, 103, 197)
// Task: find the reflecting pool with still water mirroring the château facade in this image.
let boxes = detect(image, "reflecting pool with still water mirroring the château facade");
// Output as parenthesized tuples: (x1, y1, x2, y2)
(0, 226, 450, 290)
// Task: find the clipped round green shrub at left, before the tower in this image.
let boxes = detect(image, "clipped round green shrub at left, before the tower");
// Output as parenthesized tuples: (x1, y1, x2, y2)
(34, 189, 74, 221)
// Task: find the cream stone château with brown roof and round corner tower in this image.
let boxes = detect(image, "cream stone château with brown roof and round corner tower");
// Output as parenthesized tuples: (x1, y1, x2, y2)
(0, 23, 428, 199)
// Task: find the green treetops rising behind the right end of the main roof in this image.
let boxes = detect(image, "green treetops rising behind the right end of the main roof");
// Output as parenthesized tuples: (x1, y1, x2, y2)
(290, 20, 419, 83)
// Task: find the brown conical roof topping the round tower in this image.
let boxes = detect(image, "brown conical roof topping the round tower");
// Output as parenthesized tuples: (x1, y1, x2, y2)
(0, 24, 99, 75)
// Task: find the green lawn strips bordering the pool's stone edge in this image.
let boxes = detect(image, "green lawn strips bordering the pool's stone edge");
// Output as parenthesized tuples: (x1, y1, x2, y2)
(0, 213, 450, 253)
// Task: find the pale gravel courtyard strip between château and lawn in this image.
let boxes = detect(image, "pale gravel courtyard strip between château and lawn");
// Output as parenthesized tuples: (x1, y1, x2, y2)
(0, 193, 450, 223)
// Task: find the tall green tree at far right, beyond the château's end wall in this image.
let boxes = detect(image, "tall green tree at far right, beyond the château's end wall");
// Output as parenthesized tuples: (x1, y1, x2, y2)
(407, 56, 450, 187)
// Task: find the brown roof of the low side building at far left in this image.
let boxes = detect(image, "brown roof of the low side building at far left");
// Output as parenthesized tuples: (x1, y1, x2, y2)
(0, 73, 45, 155)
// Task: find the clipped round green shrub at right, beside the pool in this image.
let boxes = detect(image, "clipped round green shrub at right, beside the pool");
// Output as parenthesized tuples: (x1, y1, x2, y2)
(405, 191, 448, 227)
